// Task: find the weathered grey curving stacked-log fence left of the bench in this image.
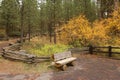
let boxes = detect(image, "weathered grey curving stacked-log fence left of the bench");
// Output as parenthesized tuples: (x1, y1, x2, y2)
(2, 43, 50, 63)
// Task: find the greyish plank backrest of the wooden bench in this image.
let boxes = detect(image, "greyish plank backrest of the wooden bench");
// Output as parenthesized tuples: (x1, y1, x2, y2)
(54, 51, 72, 61)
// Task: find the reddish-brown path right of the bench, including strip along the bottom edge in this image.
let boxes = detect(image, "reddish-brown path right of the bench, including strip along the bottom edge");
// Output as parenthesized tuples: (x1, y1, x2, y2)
(0, 56, 120, 80)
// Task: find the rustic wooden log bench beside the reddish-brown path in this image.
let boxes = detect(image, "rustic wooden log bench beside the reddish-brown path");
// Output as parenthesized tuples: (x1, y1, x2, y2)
(52, 51, 76, 70)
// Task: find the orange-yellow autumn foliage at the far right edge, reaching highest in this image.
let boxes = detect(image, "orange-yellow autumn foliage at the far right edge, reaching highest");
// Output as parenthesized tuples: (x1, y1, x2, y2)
(106, 8, 120, 38)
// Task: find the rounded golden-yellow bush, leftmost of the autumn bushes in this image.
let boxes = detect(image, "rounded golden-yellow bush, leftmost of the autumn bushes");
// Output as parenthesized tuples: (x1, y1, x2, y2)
(57, 15, 92, 45)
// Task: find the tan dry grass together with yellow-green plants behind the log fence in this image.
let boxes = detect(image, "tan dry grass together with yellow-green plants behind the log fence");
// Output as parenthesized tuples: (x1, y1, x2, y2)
(22, 37, 72, 56)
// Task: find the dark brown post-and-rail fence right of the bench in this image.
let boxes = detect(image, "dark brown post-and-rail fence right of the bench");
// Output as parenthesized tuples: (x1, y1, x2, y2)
(71, 46, 120, 57)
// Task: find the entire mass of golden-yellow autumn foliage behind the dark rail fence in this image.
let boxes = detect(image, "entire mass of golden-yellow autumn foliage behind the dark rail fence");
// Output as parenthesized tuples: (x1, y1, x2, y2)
(59, 9, 120, 46)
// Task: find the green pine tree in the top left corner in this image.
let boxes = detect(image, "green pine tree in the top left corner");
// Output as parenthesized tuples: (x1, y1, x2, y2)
(1, 0, 19, 36)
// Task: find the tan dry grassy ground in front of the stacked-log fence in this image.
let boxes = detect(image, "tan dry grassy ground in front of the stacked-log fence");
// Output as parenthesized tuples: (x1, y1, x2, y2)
(0, 58, 52, 74)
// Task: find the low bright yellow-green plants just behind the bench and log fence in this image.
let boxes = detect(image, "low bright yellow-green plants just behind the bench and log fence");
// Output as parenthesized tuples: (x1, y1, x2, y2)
(24, 43, 71, 56)
